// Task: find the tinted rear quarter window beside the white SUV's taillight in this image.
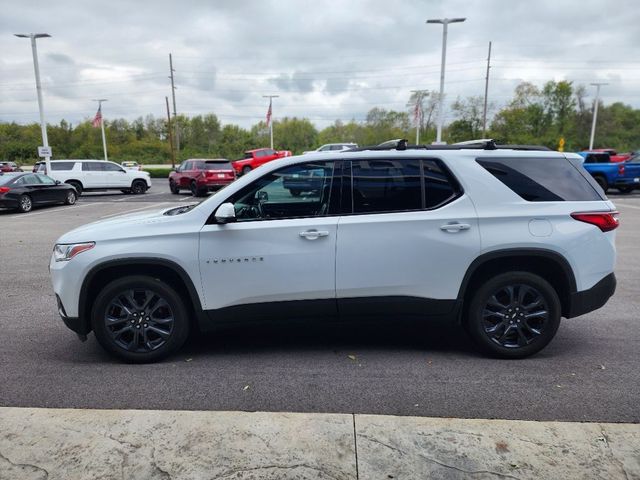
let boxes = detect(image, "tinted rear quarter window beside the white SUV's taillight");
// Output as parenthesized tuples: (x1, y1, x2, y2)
(477, 157, 603, 202)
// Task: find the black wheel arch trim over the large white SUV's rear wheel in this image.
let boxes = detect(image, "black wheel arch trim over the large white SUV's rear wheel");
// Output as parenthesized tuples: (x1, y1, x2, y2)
(457, 248, 577, 320)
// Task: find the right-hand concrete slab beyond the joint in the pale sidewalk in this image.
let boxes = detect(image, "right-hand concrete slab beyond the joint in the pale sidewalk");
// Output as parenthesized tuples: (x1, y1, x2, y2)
(355, 415, 640, 480)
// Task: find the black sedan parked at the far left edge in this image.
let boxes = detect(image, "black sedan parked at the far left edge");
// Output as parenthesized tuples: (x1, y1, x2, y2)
(0, 173, 78, 212)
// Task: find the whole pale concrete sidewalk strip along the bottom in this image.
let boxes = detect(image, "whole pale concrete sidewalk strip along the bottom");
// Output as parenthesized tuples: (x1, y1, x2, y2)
(0, 408, 640, 480)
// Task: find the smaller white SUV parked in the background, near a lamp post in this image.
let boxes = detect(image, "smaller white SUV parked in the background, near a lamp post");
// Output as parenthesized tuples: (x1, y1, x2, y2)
(37, 160, 151, 195)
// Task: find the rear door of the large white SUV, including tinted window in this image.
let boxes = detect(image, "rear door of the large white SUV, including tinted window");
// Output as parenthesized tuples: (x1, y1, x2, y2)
(336, 157, 480, 315)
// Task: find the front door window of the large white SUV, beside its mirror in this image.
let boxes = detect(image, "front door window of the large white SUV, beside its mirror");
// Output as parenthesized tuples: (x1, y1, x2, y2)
(227, 162, 334, 222)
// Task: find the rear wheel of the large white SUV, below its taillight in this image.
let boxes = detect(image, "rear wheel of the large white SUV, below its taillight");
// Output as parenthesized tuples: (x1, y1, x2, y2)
(464, 272, 562, 358)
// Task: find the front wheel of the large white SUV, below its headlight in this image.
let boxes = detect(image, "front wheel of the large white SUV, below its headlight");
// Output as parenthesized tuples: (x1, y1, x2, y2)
(91, 275, 189, 363)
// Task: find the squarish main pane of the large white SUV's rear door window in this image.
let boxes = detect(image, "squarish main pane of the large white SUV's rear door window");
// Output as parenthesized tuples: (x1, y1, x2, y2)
(351, 160, 423, 213)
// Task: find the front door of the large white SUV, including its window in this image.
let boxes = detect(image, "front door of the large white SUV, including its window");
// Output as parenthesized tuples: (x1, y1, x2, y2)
(200, 162, 338, 321)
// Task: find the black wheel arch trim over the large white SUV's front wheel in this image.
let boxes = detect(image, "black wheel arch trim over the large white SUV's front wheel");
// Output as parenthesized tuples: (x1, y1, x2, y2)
(78, 257, 206, 333)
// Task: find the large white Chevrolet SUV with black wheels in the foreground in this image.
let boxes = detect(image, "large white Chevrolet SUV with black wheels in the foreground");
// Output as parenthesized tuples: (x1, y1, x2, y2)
(50, 143, 618, 362)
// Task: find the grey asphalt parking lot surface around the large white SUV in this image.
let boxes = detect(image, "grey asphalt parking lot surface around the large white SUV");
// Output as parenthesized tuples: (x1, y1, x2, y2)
(0, 180, 640, 422)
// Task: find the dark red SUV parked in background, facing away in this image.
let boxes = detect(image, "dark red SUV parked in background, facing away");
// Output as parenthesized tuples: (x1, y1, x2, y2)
(169, 158, 236, 197)
